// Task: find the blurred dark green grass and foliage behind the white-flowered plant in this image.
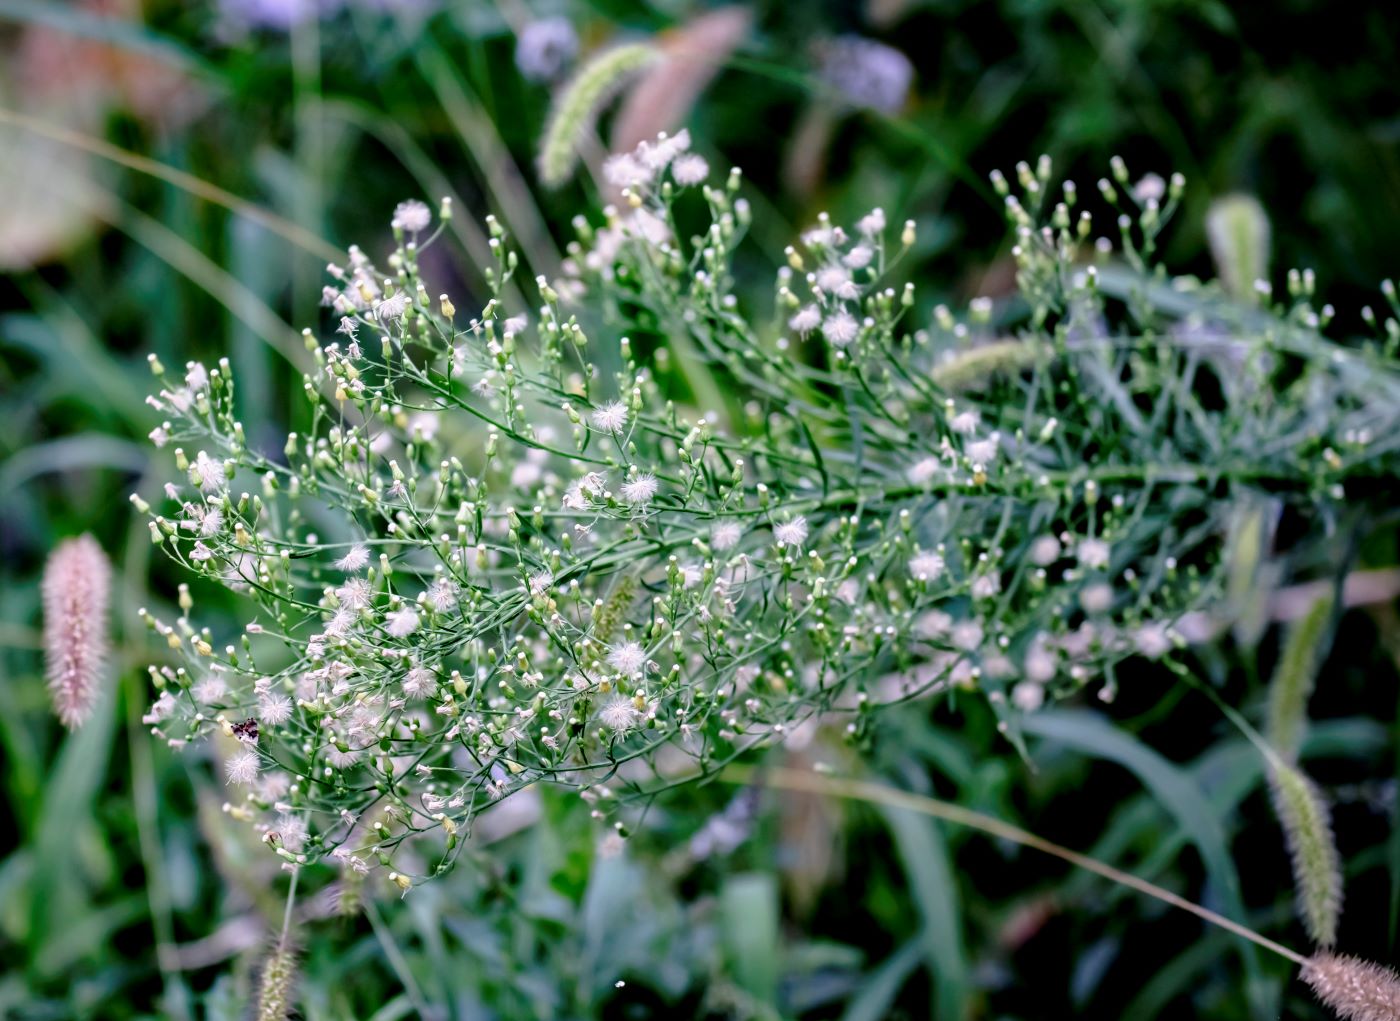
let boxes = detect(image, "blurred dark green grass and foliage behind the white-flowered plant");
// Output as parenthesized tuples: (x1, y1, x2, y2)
(0, 0, 1400, 1020)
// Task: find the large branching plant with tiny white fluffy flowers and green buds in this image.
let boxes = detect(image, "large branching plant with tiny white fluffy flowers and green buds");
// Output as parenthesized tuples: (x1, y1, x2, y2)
(137, 132, 1400, 891)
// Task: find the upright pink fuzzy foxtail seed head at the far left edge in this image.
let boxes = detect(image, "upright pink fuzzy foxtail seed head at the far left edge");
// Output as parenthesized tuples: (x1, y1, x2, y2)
(43, 535, 112, 728)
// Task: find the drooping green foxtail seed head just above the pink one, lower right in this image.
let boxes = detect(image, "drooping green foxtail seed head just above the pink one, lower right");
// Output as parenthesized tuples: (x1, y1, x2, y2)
(1271, 763, 1341, 947)
